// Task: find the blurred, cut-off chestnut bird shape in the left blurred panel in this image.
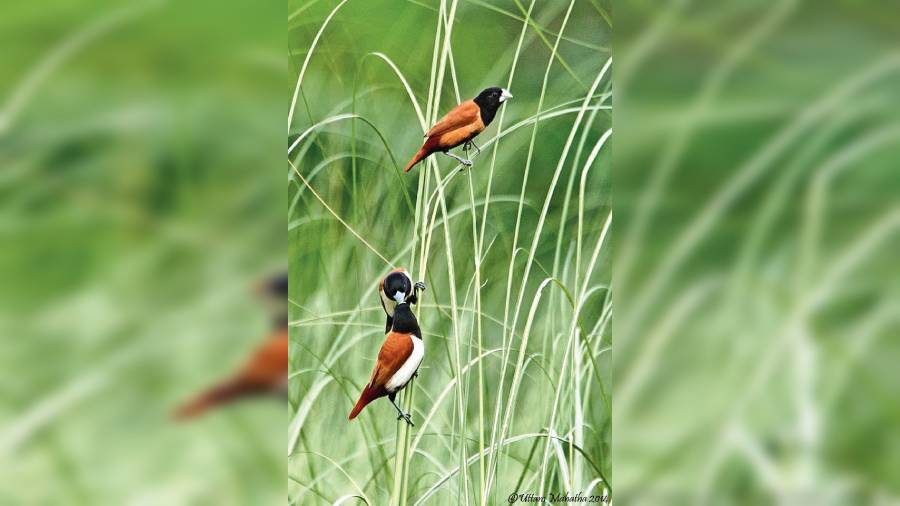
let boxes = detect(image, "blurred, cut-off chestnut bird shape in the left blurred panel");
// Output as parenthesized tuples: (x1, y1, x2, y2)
(174, 274, 288, 420)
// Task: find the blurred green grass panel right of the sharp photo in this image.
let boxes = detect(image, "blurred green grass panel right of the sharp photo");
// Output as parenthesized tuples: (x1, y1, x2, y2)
(613, 0, 900, 506)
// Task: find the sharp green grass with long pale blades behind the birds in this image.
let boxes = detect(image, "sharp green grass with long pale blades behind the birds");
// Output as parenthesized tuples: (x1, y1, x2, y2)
(287, 0, 612, 505)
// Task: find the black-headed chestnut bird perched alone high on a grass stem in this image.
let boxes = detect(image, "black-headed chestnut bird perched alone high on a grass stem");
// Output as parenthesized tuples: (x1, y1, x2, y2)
(404, 87, 512, 172)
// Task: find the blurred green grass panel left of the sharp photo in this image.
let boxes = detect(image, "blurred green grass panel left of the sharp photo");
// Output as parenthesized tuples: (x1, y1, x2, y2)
(0, 0, 287, 505)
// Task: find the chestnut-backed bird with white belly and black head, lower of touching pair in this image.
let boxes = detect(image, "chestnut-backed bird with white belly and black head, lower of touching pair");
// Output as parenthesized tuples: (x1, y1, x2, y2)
(349, 302, 425, 425)
